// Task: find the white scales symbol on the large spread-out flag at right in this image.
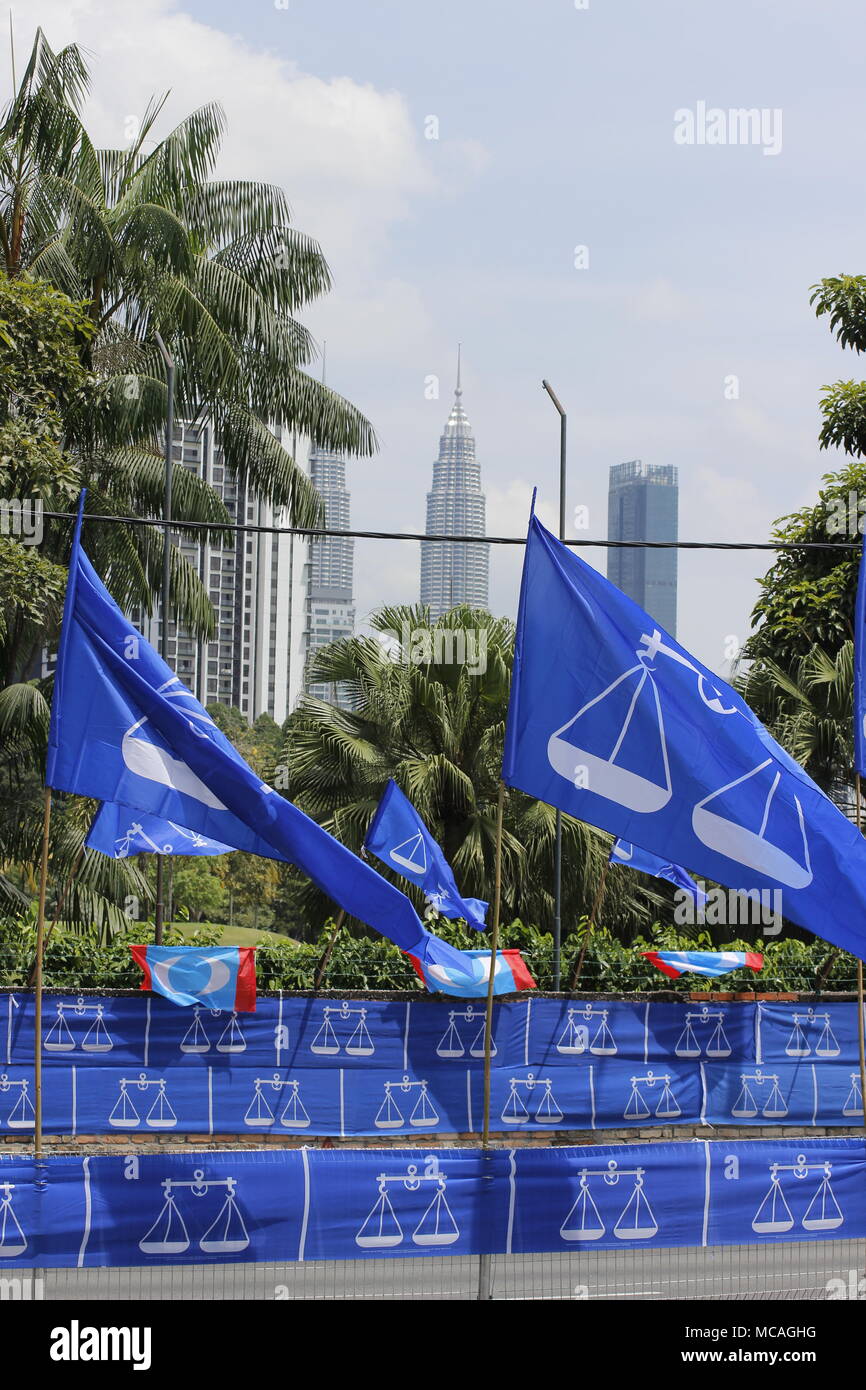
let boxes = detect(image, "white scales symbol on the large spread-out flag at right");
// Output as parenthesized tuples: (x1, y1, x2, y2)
(548, 628, 812, 888)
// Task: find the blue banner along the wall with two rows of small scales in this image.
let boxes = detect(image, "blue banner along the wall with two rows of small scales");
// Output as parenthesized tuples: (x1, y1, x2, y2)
(0, 992, 863, 1137)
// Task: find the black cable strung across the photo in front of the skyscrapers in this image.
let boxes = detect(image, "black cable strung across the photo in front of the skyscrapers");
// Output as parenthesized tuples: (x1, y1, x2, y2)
(42, 512, 860, 550)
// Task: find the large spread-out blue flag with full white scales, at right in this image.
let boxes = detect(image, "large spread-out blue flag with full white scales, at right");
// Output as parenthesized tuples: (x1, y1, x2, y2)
(503, 517, 866, 956)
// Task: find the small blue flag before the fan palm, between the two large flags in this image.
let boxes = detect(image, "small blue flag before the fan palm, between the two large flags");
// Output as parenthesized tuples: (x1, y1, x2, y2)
(364, 780, 488, 931)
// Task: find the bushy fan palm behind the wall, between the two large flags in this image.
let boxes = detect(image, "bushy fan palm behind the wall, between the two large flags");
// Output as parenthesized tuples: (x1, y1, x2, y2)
(284, 606, 650, 931)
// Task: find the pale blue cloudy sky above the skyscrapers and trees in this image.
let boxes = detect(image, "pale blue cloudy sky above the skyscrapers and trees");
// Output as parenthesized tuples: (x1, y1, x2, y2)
(15, 0, 866, 671)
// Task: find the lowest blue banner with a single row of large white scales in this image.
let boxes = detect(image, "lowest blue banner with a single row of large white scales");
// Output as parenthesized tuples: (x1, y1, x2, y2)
(0, 1137, 866, 1273)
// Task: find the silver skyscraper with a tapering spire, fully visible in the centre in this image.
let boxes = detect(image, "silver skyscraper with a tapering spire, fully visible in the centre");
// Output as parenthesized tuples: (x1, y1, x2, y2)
(421, 353, 489, 619)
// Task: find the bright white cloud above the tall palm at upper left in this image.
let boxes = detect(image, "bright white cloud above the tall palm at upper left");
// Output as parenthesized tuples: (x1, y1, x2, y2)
(17, 0, 436, 265)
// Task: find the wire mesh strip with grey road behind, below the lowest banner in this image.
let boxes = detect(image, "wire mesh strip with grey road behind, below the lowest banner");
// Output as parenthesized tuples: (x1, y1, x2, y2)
(0, 1240, 866, 1302)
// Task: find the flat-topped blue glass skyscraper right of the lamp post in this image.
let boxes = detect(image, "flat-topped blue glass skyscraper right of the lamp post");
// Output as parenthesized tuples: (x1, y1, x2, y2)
(607, 459, 680, 637)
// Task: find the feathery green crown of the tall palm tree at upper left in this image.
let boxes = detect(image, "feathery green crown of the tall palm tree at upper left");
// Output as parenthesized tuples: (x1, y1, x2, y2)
(0, 33, 375, 514)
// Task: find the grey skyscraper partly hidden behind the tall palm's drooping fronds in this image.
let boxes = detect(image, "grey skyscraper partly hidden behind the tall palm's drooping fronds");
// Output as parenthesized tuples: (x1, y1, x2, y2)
(304, 449, 354, 705)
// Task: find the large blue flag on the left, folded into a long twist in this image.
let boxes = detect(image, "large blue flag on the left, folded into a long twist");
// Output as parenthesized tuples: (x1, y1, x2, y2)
(46, 507, 460, 967)
